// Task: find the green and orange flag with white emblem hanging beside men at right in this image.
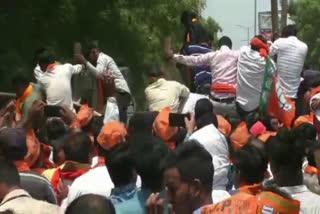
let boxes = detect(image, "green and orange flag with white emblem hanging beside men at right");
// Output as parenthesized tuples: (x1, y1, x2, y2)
(260, 58, 296, 127)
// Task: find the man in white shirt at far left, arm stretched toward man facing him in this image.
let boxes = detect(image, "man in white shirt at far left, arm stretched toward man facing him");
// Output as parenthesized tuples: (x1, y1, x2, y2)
(38, 51, 84, 109)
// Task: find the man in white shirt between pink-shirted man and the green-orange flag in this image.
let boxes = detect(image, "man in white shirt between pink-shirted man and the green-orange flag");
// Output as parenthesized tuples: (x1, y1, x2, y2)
(236, 36, 266, 117)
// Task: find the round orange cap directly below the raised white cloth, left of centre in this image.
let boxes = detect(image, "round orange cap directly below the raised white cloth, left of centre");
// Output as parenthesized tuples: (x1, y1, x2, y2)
(97, 120, 127, 150)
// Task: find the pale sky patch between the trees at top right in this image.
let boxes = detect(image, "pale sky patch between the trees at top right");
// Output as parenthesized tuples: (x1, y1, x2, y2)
(203, 0, 280, 48)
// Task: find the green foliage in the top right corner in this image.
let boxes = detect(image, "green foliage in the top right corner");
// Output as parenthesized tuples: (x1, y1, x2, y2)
(292, 0, 320, 69)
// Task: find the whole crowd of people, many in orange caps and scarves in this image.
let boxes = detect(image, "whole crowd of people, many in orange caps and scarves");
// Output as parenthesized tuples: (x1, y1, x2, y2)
(0, 12, 320, 214)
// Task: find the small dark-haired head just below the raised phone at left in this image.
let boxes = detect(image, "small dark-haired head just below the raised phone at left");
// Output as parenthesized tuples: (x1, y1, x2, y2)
(45, 118, 68, 142)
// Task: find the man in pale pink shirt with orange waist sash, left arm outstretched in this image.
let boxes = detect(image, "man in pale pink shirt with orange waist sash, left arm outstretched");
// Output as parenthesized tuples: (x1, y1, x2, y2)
(173, 36, 239, 117)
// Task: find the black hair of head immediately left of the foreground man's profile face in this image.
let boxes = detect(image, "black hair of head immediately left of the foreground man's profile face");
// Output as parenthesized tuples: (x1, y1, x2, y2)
(128, 134, 169, 191)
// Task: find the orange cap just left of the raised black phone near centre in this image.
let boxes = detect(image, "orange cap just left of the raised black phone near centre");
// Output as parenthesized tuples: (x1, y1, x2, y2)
(153, 107, 178, 141)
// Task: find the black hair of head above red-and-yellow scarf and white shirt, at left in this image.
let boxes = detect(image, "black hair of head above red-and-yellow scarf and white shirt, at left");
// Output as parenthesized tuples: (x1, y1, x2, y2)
(63, 132, 92, 163)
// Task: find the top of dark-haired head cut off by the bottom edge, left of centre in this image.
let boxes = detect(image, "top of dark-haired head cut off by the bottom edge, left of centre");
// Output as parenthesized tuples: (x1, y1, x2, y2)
(66, 194, 116, 214)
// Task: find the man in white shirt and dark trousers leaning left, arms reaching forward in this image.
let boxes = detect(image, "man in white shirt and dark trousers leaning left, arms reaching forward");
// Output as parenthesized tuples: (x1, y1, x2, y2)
(75, 44, 131, 123)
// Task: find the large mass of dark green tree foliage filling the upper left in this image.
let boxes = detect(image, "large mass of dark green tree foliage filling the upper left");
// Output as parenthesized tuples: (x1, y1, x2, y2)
(0, 0, 220, 108)
